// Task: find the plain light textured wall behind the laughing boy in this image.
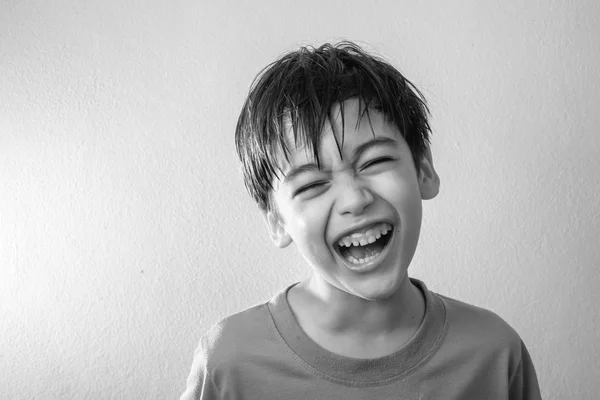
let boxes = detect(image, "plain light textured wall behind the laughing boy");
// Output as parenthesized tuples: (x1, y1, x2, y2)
(0, 0, 600, 399)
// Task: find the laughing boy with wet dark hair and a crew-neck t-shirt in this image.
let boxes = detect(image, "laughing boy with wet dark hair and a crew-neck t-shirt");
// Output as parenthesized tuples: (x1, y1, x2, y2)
(181, 42, 540, 400)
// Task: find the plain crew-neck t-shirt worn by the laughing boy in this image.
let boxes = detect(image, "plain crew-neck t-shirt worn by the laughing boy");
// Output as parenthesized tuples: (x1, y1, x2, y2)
(181, 278, 541, 400)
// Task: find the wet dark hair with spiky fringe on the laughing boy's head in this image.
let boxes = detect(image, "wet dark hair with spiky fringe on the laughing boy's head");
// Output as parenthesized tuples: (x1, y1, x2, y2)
(235, 41, 430, 211)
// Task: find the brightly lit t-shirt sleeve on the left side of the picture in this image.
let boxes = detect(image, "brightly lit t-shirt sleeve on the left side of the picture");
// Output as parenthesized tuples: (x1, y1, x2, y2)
(180, 337, 222, 400)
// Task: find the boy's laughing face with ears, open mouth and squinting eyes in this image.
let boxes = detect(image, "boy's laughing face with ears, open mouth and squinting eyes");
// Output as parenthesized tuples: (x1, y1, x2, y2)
(266, 99, 439, 300)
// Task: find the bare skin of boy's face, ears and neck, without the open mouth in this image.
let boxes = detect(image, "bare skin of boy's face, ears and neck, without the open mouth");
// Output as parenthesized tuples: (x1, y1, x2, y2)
(265, 98, 440, 358)
